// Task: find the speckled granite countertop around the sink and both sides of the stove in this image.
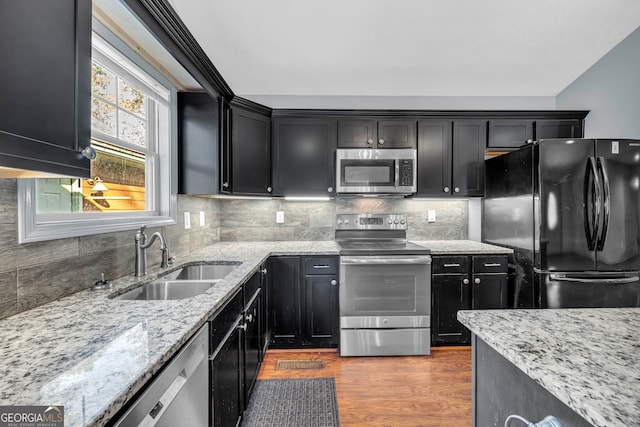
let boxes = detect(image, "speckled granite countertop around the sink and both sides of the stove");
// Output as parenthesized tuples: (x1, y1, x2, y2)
(0, 241, 510, 427)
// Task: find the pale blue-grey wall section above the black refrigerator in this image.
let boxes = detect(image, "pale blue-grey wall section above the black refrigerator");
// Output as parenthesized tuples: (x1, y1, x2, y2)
(556, 28, 640, 139)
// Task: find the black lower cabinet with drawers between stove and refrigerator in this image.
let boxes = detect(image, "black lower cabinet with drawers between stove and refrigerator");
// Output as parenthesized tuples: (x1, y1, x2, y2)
(431, 255, 508, 346)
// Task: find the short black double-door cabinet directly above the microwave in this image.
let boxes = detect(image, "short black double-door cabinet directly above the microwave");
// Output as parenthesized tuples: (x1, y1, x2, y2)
(338, 119, 416, 148)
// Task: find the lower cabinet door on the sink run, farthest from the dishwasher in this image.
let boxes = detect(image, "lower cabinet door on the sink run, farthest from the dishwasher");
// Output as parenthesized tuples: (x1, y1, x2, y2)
(244, 290, 262, 409)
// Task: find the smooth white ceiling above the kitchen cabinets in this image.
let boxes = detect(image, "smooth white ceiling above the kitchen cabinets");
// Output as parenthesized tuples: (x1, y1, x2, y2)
(164, 0, 640, 107)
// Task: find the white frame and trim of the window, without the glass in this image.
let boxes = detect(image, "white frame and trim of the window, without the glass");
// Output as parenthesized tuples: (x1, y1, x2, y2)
(18, 19, 178, 243)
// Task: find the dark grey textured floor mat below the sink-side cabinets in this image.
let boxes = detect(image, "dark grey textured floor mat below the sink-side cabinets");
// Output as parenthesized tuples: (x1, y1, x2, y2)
(242, 378, 340, 427)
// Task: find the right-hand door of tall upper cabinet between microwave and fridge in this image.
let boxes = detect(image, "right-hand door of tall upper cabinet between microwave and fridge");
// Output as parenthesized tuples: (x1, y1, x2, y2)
(452, 120, 487, 196)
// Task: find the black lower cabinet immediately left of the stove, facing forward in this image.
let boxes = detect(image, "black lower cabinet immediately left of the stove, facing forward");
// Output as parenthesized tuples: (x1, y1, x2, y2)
(268, 256, 339, 348)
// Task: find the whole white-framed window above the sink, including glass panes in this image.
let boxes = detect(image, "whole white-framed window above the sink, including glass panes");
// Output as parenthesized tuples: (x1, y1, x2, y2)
(18, 24, 176, 243)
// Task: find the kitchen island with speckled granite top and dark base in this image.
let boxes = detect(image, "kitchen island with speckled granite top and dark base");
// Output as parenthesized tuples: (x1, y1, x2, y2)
(458, 308, 640, 427)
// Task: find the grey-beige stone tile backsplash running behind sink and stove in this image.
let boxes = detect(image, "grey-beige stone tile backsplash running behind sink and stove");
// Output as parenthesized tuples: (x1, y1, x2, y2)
(0, 179, 469, 318)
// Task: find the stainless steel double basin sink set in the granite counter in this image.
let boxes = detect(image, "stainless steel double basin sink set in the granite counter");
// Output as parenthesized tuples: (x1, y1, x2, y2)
(115, 261, 241, 300)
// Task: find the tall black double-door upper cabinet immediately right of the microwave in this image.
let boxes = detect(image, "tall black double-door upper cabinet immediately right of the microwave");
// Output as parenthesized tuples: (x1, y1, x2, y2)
(417, 119, 486, 196)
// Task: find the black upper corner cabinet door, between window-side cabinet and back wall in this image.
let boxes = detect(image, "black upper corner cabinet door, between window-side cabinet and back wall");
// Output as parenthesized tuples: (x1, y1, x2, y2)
(230, 107, 271, 195)
